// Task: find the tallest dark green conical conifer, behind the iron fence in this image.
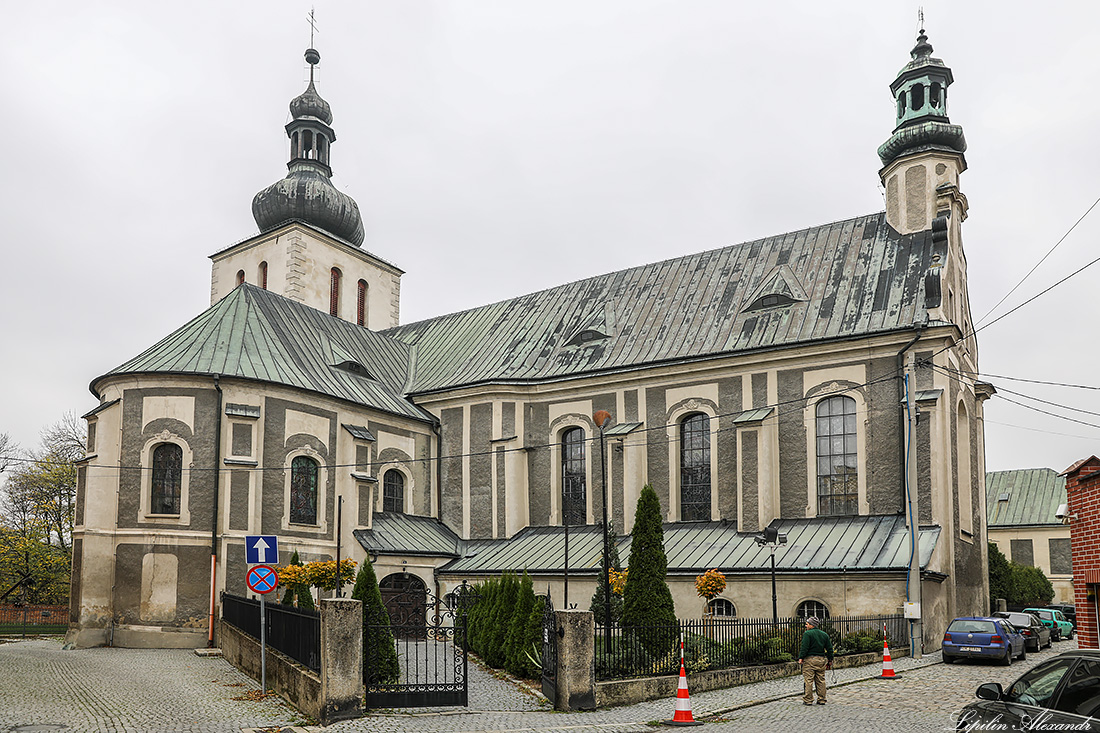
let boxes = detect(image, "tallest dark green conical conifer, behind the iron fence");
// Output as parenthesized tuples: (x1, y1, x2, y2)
(623, 484, 679, 656)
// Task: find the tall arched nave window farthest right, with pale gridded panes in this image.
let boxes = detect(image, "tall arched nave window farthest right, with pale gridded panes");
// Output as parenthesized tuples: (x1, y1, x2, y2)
(817, 396, 859, 516)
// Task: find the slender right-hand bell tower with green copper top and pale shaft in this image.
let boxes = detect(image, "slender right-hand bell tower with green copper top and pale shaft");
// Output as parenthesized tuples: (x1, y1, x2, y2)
(879, 29, 967, 234)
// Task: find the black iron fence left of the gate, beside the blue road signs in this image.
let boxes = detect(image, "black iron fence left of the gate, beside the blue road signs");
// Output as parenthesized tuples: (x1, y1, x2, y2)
(221, 593, 321, 671)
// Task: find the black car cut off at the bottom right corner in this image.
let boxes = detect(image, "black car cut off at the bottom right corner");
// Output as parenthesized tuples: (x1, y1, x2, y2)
(955, 649, 1100, 731)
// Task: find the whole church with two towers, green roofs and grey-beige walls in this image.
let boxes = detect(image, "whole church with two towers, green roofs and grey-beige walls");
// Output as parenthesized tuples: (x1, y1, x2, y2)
(69, 31, 993, 650)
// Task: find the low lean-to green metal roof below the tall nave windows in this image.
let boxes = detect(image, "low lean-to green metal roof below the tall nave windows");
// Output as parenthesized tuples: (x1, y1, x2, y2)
(440, 514, 939, 575)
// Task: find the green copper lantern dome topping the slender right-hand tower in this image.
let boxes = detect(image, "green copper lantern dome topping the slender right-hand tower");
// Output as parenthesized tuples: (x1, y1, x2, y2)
(879, 29, 966, 165)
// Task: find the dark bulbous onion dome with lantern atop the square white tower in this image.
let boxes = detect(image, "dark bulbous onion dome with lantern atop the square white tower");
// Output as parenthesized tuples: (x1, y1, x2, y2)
(252, 48, 364, 247)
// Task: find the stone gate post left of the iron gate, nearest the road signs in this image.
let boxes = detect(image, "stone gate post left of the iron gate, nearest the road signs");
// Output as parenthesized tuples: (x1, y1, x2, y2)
(320, 598, 364, 724)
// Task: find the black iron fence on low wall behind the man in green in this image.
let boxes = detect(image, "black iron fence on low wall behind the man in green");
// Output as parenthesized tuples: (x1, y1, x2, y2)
(596, 615, 908, 680)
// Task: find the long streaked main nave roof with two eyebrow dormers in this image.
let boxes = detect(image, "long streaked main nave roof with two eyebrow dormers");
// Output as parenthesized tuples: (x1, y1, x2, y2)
(383, 214, 933, 394)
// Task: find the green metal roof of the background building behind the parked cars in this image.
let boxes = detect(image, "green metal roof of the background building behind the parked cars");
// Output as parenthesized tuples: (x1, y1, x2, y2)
(986, 469, 1066, 529)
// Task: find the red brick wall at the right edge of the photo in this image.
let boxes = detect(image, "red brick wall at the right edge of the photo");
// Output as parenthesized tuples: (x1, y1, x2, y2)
(1066, 456, 1100, 649)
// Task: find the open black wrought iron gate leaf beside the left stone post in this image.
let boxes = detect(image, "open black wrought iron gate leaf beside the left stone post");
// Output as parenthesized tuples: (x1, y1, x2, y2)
(363, 582, 474, 708)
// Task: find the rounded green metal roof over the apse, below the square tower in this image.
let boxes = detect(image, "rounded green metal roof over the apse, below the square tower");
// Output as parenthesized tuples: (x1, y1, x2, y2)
(91, 284, 431, 420)
